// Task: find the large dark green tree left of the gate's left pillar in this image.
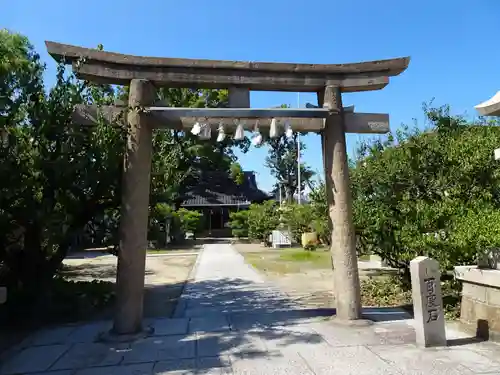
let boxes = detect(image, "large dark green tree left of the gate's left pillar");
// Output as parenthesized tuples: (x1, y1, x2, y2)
(0, 30, 124, 290)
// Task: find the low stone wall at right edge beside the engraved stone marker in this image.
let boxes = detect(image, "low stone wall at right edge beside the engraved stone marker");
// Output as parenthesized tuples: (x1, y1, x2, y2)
(455, 266, 500, 341)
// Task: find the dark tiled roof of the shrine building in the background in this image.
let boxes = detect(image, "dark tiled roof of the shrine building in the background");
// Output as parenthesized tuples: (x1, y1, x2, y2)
(181, 172, 271, 207)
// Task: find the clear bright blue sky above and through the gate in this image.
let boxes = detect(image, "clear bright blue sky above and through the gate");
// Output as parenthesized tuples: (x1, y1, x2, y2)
(0, 0, 500, 190)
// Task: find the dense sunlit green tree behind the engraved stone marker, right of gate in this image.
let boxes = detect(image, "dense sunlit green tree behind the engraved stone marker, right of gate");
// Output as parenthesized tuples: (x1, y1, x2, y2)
(351, 106, 500, 282)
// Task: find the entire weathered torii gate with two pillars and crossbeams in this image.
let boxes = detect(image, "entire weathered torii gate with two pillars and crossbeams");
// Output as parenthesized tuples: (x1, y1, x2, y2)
(46, 42, 409, 335)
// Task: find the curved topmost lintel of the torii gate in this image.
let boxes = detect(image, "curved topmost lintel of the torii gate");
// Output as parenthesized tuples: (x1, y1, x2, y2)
(45, 41, 410, 92)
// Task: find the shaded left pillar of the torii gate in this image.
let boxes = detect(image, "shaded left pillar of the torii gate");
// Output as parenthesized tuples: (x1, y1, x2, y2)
(113, 79, 155, 335)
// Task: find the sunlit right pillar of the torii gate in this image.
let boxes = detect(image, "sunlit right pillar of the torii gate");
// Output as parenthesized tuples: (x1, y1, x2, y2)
(322, 86, 361, 320)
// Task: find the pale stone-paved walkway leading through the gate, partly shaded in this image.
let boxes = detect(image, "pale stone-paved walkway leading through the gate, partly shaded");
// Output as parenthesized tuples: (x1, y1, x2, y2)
(0, 244, 500, 375)
